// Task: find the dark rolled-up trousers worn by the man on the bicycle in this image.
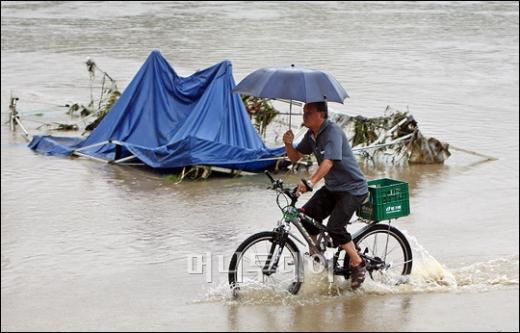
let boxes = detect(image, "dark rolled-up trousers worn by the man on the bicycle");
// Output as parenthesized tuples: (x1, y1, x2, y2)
(303, 186, 368, 246)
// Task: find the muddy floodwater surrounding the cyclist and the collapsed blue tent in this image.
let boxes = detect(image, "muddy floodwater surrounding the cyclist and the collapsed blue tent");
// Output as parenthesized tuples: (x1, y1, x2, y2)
(1, 2, 519, 331)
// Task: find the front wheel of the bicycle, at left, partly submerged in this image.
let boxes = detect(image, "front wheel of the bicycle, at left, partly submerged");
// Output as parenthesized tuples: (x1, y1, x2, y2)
(228, 231, 303, 296)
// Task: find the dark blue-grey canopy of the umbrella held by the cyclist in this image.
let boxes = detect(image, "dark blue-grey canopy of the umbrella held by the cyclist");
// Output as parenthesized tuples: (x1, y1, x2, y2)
(233, 65, 348, 103)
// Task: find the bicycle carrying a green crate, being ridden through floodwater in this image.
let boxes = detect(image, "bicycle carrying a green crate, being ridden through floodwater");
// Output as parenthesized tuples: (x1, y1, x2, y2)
(228, 171, 413, 296)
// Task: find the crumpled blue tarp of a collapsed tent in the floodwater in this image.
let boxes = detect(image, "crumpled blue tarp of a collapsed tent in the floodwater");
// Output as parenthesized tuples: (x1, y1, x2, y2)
(29, 50, 285, 171)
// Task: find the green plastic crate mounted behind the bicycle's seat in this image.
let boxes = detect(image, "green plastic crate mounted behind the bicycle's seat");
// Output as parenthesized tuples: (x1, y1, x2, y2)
(357, 178, 410, 221)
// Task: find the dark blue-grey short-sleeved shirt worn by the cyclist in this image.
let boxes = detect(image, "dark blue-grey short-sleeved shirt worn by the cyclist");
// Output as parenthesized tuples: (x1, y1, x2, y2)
(296, 120, 368, 195)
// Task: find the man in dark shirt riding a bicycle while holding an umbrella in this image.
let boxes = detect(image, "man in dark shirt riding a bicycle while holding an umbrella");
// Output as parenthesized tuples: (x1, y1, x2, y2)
(283, 102, 368, 289)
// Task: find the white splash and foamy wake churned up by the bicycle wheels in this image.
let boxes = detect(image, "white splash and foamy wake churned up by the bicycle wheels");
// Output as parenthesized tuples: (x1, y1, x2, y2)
(195, 231, 519, 305)
